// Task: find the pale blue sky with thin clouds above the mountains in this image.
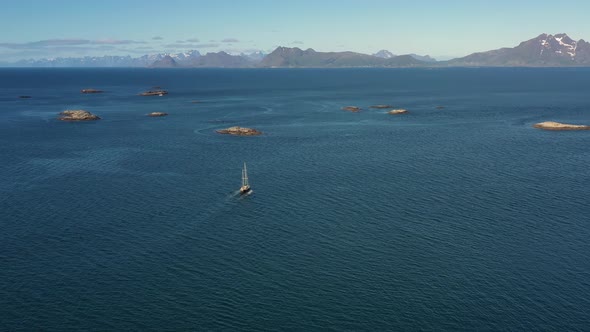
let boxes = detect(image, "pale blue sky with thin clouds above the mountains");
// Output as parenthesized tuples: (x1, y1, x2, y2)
(0, 0, 590, 62)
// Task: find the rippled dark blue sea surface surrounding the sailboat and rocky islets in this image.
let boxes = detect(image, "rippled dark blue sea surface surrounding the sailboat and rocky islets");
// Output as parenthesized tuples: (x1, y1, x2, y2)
(0, 68, 590, 331)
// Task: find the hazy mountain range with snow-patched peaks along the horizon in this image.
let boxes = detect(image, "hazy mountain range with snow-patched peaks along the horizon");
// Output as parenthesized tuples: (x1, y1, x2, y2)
(8, 33, 590, 68)
